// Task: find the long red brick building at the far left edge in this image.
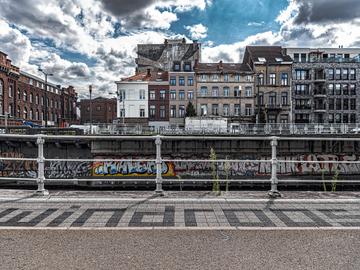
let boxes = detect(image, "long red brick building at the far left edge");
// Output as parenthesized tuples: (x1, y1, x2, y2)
(0, 52, 77, 126)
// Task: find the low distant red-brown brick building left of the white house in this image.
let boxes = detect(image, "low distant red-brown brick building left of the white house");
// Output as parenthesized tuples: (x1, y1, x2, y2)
(80, 97, 116, 124)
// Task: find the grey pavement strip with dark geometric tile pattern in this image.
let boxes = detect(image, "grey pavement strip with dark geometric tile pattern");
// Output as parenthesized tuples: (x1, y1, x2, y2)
(0, 200, 360, 227)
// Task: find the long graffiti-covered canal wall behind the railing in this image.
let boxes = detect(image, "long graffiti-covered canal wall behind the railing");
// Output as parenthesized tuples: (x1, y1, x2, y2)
(0, 152, 360, 179)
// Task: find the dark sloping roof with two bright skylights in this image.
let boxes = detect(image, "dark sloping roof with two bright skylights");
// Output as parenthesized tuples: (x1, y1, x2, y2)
(246, 46, 293, 64)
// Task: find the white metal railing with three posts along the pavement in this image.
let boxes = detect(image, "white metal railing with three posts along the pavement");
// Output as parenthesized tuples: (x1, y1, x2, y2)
(0, 134, 360, 197)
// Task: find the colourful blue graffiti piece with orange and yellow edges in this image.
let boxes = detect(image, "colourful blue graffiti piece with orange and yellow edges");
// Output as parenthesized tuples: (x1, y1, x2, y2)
(92, 161, 175, 177)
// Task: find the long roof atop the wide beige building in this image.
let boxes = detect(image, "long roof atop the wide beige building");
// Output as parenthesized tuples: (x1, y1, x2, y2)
(195, 61, 252, 73)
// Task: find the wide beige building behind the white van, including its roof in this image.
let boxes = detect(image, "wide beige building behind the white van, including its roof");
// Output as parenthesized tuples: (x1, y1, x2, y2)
(195, 61, 255, 123)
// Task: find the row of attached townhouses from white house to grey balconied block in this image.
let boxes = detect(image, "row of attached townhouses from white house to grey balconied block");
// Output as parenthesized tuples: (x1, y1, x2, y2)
(117, 40, 360, 127)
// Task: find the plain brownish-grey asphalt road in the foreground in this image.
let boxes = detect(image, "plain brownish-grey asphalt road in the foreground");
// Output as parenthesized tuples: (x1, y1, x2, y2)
(0, 229, 360, 270)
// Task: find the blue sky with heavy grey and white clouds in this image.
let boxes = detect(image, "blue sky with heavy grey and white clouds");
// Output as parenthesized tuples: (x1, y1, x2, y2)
(0, 0, 360, 98)
